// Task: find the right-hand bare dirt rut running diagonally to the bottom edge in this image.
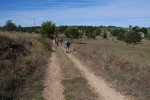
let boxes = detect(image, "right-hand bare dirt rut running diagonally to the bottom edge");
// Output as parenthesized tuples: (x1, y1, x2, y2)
(61, 47, 131, 100)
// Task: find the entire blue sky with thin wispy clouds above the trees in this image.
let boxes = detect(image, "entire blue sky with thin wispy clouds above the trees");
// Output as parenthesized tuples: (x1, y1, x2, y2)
(0, 0, 150, 27)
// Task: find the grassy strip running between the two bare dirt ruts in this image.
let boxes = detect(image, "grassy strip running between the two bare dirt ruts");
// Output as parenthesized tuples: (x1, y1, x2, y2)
(58, 47, 98, 100)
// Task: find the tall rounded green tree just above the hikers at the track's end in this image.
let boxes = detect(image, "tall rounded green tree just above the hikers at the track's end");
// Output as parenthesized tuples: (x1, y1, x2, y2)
(41, 21, 55, 39)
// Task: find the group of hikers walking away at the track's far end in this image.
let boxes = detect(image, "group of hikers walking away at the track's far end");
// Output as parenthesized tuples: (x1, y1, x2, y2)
(53, 36, 71, 53)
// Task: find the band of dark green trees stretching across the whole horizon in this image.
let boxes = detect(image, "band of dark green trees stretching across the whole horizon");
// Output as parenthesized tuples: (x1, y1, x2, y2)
(0, 20, 150, 44)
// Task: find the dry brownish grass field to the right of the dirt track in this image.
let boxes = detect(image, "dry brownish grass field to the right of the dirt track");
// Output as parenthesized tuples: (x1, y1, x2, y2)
(73, 38, 150, 100)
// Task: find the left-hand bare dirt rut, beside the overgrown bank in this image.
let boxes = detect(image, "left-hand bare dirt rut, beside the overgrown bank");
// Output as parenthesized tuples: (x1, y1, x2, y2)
(43, 53, 64, 100)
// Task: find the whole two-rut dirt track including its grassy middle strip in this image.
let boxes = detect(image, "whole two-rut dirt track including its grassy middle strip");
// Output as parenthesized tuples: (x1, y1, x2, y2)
(43, 48, 130, 100)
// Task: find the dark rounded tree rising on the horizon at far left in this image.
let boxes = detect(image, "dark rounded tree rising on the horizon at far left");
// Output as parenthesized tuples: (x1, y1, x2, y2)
(4, 20, 17, 31)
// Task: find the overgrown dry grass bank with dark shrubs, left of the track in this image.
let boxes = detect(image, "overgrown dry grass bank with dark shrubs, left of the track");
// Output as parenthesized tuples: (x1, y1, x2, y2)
(0, 32, 50, 100)
